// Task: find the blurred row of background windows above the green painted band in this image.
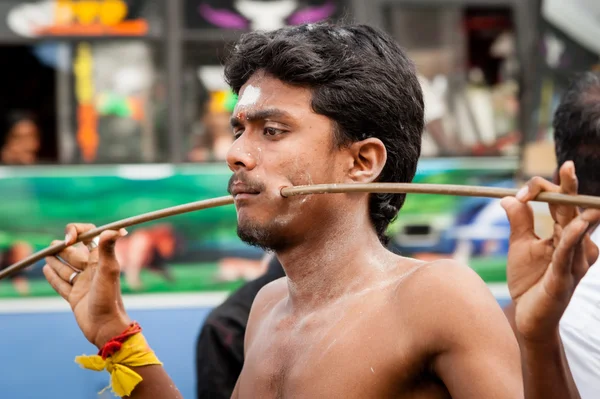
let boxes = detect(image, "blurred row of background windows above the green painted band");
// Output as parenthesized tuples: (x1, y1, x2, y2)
(0, 0, 556, 164)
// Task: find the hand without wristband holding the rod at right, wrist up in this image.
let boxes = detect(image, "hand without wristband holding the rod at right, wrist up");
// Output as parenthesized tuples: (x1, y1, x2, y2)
(502, 162, 600, 343)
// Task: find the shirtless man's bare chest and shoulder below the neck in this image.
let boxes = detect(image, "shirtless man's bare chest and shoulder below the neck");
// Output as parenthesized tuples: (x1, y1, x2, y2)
(234, 258, 519, 398)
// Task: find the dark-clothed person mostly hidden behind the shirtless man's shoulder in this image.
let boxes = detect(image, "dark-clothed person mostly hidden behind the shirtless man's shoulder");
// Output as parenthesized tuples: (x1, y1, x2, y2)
(196, 254, 285, 399)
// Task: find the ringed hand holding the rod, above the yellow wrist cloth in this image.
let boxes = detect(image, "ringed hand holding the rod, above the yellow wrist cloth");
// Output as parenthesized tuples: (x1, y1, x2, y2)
(43, 224, 131, 348)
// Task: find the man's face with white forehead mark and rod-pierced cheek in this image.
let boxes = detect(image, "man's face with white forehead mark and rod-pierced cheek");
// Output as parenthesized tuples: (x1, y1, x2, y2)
(227, 73, 351, 250)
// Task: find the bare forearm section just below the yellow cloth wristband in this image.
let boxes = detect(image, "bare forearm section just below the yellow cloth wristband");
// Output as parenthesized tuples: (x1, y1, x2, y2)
(127, 366, 183, 399)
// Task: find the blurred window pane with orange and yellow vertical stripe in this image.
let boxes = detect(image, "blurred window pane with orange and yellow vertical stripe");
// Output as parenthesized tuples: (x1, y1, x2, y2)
(72, 40, 168, 163)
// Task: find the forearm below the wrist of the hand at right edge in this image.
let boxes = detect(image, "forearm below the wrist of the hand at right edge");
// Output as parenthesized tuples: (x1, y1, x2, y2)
(519, 332, 580, 399)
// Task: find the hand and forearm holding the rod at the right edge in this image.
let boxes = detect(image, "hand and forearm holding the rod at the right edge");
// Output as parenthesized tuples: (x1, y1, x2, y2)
(502, 163, 600, 399)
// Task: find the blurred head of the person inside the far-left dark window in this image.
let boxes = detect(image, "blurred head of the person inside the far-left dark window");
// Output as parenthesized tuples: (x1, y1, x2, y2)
(0, 111, 40, 165)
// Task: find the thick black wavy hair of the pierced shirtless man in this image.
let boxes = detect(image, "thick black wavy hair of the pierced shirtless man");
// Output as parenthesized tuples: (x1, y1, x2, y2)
(225, 23, 424, 244)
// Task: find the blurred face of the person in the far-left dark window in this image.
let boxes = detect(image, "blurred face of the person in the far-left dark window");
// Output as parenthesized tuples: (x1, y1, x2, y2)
(0, 119, 40, 165)
